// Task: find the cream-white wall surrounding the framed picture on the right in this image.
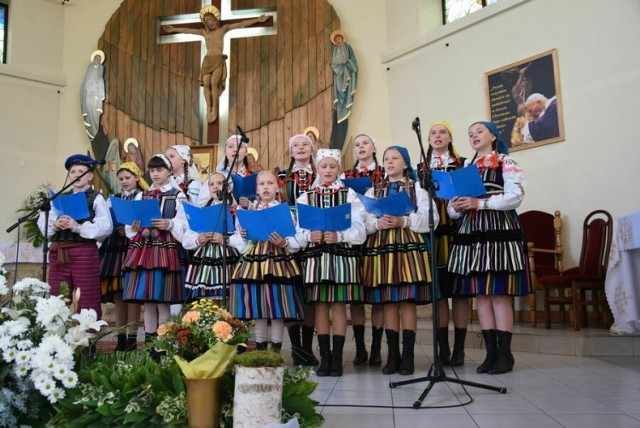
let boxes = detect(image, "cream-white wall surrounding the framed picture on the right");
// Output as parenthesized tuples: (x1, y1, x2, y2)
(382, 0, 640, 267)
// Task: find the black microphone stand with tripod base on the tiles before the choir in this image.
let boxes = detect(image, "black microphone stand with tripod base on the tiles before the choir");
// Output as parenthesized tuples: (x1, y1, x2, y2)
(389, 118, 507, 409)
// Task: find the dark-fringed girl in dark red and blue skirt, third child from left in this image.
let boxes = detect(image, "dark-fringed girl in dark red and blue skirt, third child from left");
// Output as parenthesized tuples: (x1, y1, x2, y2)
(122, 153, 187, 350)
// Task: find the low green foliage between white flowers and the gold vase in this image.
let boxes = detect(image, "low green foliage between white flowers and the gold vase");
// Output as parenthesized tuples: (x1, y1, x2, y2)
(52, 352, 187, 428)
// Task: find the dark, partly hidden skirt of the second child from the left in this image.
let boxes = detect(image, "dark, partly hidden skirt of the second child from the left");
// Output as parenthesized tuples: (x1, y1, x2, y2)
(100, 231, 129, 303)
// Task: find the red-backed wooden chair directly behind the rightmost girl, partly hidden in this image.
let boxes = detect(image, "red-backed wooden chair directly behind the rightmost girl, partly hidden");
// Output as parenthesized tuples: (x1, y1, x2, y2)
(519, 211, 564, 327)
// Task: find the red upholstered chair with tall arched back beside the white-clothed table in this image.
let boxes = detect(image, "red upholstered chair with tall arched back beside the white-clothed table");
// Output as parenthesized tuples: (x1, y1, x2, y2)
(538, 210, 613, 330)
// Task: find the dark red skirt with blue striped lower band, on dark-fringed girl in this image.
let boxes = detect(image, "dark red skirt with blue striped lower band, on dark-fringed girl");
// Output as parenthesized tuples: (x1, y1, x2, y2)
(122, 231, 186, 303)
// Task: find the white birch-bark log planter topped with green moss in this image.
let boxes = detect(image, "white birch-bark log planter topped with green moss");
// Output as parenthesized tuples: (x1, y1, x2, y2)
(233, 351, 284, 427)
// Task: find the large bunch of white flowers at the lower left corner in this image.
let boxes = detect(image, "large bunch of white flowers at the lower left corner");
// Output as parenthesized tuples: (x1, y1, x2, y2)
(0, 260, 106, 426)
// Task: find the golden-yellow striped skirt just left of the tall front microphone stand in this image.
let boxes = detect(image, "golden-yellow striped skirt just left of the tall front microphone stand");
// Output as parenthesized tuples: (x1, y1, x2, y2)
(362, 228, 431, 304)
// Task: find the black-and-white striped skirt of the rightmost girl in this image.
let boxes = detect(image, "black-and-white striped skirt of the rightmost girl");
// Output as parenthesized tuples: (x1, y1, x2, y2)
(449, 210, 531, 296)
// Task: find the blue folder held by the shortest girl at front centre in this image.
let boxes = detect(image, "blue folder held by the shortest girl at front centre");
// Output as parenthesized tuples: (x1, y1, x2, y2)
(236, 204, 296, 241)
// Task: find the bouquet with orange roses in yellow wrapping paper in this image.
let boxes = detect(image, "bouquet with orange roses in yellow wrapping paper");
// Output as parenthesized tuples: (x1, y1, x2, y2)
(154, 299, 250, 378)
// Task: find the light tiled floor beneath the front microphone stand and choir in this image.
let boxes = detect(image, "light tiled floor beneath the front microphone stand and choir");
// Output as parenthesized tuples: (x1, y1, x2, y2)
(283, 322, 640, 428)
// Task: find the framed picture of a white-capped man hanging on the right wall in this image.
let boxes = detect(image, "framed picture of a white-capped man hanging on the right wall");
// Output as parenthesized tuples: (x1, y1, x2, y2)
(485, 49, 564, 151)
